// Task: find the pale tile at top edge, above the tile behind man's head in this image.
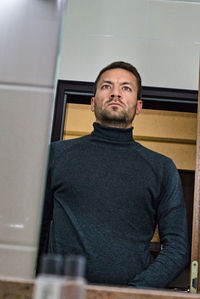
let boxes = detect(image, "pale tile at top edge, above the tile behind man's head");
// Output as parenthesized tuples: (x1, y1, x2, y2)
(65, 0, 148, 38)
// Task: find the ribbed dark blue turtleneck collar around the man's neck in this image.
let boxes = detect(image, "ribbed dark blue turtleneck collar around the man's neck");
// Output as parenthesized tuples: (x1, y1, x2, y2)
(92, 122, 134, 142)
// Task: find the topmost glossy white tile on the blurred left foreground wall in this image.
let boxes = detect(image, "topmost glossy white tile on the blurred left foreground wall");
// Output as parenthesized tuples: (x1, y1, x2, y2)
(0, 0, 62, 87)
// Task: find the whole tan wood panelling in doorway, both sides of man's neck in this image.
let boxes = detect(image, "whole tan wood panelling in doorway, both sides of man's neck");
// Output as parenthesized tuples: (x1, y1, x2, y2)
(63, 104, 197, 170)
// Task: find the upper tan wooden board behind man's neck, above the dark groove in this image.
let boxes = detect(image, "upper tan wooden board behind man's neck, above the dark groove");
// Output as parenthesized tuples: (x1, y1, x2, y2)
(64, 104, 197, 144)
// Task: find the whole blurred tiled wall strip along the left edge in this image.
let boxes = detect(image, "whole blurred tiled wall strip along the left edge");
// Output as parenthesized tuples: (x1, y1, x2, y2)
(0, 0, 64, 278)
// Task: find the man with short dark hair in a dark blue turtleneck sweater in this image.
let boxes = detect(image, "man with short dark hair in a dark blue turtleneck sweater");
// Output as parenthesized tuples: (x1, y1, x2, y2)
(41, 62, 189, 287)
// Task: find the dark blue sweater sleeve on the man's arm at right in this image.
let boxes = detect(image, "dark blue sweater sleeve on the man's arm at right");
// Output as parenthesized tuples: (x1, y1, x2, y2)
(129, 161, 190, 288)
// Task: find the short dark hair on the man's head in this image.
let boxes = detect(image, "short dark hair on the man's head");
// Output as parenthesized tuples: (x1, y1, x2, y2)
(94, 61, 142, 100)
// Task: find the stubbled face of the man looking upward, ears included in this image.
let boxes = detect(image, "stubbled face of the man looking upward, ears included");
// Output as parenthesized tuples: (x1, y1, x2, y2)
(91, 68, 142, 128)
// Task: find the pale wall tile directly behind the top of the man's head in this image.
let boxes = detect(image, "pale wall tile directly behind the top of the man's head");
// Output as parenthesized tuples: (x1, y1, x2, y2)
(60, 35, 146, 81)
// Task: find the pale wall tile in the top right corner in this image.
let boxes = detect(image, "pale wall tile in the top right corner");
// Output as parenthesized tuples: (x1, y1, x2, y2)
(148, 0, 200, 43)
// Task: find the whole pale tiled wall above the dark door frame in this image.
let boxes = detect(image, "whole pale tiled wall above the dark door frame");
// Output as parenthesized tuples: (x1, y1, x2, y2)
(59, 0, 200, 90)
